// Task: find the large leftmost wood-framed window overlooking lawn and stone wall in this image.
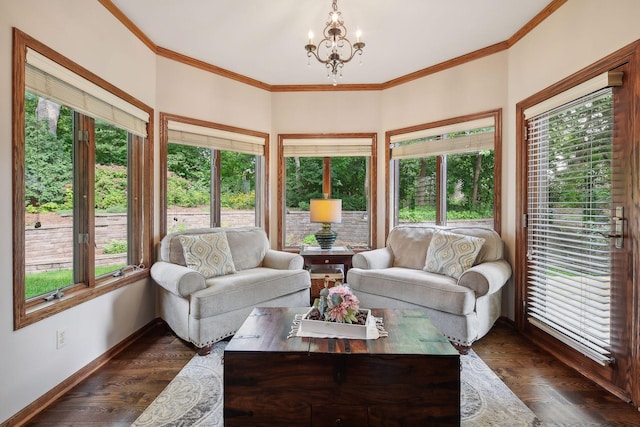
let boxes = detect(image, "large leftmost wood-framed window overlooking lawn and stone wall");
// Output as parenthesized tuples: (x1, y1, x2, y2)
(13, 30, 153, 328)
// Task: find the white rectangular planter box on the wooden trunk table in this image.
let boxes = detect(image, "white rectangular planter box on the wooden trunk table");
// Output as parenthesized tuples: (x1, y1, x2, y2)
(298, 309, 379, 340)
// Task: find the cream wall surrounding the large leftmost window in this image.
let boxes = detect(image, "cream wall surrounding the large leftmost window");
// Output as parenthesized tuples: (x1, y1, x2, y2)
(0, 0, 156, 422)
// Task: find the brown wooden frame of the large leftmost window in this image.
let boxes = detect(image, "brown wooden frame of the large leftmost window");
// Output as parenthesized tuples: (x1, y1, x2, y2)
(12, 28, 154, 330)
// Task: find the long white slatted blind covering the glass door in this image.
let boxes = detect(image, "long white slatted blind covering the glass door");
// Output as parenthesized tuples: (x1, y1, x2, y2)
(527, 88, 613, 365)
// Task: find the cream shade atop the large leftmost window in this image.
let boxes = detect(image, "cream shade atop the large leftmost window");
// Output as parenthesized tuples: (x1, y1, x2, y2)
(25, 49, 149, 138)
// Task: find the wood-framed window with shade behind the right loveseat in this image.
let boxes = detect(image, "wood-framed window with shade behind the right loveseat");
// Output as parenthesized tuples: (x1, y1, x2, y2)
(387, 111, 500, 236)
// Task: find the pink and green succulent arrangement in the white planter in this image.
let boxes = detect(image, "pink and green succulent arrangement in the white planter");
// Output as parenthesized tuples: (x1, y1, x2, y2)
(308, 285, 366, 324)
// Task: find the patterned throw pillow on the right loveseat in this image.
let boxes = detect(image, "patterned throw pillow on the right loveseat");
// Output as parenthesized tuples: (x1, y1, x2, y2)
(423, 230, 484, 279)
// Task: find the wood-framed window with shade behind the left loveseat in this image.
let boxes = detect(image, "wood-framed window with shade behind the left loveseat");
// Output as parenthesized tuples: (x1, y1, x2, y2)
(160, 113, 269, 234)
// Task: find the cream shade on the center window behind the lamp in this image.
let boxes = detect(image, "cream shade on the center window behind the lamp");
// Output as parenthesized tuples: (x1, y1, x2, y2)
(282, 138, 373, 157)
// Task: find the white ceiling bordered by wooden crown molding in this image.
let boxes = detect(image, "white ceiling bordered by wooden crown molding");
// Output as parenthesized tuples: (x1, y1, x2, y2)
(111, 0, 552, 85)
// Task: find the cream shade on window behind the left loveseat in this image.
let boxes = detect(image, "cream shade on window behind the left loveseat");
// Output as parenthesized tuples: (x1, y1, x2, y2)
(167, 120, 266, 156)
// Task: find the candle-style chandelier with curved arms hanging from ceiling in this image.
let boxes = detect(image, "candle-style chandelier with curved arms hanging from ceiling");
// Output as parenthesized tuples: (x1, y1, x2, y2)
(304, 0, 364, 86)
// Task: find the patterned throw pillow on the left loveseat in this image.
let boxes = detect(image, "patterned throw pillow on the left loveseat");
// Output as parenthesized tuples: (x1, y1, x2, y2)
(179, 232, 236, 279)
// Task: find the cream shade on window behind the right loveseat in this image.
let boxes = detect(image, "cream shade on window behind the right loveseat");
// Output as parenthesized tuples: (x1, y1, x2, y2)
(390, 117, 495, 159)
